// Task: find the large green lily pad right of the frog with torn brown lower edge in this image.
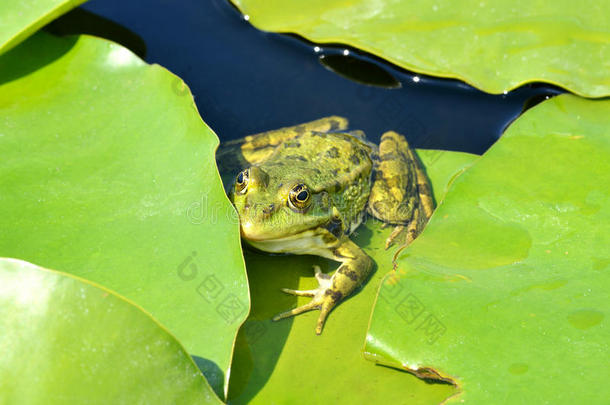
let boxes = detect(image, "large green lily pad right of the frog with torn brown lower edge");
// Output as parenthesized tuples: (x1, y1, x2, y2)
(366, 95, 610, 404)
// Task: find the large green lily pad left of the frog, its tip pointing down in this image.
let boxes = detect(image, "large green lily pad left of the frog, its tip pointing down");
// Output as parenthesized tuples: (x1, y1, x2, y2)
(0, 34, 249, 393)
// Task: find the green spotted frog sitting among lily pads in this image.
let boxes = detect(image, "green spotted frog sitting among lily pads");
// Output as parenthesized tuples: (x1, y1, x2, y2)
(216, 116, 434, 335)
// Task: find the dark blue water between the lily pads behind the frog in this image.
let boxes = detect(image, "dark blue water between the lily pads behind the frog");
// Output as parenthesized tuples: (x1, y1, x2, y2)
(46, 0, 559, 153)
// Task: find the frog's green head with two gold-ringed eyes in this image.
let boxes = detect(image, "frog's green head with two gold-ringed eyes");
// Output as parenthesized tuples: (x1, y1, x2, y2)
(231, 166, 333, 241)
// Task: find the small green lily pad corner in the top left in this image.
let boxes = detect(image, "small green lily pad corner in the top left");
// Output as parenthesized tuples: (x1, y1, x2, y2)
(0, 0, 86, 54)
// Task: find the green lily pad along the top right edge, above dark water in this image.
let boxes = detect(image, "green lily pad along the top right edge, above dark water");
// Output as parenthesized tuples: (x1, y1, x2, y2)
(232, 0, 610, 97)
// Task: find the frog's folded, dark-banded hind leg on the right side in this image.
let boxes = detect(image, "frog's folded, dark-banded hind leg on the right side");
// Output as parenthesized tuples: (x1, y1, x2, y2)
(369, 131, 434, 249)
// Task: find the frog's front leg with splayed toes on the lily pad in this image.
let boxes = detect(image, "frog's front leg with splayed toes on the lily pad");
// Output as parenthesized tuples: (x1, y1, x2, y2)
(273, 236, 373, 335)
